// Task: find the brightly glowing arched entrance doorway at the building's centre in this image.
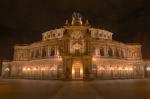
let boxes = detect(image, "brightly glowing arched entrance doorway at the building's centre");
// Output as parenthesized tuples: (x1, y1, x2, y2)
(72, 61, 83, 80)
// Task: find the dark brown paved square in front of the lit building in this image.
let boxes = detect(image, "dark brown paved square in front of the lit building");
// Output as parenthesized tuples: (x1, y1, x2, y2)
(0, 79, 150, 99)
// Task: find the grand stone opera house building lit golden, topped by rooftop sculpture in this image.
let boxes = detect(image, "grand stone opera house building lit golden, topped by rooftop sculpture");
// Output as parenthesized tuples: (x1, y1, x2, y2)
(2, 13, 150, 80)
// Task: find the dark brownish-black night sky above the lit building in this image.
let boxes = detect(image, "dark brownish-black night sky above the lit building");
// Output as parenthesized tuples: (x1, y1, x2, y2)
(0, 0, 150, 59)
